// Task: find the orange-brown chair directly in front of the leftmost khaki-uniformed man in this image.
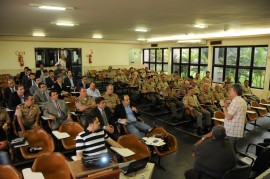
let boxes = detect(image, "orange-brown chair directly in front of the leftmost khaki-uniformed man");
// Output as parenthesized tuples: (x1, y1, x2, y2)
(20, 128, 54, 159)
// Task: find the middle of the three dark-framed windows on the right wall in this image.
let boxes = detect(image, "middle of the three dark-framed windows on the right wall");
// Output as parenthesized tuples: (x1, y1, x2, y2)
(172, 47, 208, 78)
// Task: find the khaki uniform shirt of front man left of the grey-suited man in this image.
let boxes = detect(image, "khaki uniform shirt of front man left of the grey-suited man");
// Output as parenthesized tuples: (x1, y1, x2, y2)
(15, 104, 41, 126)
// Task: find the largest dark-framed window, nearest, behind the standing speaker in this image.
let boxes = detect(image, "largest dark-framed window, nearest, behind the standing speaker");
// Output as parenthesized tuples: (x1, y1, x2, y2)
(212, 45, 268, 88)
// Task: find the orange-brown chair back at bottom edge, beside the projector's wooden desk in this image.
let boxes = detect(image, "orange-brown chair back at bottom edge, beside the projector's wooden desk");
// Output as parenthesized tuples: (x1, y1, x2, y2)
(32, 152, 71, 179)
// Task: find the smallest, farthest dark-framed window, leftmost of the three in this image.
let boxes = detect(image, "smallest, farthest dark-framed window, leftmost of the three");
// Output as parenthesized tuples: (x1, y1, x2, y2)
(143, 48, 169, 72)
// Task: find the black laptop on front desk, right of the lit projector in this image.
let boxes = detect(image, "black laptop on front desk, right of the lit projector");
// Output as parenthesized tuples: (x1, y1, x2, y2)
(121, 157, 149, 175)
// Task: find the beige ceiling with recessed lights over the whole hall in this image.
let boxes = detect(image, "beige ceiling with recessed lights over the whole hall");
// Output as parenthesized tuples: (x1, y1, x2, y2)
(0, 0, 270, 41)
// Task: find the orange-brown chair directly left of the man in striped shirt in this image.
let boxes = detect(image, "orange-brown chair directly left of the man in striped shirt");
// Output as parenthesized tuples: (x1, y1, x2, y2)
(59, 122, 83, 150)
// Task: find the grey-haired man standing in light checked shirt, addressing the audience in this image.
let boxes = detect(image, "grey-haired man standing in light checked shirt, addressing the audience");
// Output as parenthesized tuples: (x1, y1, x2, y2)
(220, 83, 247, 151)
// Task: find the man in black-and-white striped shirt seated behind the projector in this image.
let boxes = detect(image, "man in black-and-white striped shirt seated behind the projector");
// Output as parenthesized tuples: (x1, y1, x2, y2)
(76, 115, 122, 160)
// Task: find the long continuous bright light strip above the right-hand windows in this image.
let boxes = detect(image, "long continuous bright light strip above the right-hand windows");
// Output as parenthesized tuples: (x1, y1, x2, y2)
(147, 28, 270, 42)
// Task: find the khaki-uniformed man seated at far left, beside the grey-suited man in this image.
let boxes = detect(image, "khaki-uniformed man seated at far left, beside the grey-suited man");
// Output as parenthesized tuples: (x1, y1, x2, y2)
(15, 94, 41, 135)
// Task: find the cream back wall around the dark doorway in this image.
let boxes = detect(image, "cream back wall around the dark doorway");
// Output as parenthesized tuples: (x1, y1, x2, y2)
(0, 41, 140, 74)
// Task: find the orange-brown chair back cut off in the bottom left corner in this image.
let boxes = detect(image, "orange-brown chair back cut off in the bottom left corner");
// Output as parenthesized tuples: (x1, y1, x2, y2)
(0, 165, 22, 179)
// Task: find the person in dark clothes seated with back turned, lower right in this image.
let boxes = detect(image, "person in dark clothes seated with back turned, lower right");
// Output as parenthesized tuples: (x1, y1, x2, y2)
(185, 126, 237, 179)
